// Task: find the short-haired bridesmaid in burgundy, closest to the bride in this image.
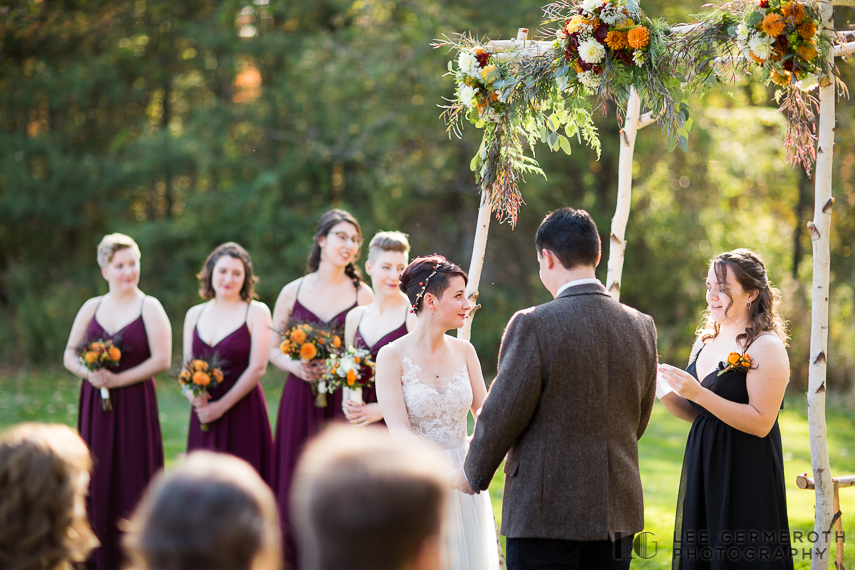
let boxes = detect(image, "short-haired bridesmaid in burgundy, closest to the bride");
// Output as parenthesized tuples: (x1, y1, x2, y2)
(342, 232, 416, 427)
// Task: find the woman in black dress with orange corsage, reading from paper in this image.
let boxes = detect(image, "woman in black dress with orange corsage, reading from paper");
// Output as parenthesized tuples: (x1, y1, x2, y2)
(659, 249, 793, 570)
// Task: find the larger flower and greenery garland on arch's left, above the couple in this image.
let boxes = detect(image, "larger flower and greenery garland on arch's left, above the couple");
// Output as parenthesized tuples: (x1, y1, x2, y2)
(433, 0, 689, 225)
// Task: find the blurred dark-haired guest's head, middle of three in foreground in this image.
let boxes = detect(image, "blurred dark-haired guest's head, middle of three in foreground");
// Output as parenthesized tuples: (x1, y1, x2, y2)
(124, 451, 282, 570)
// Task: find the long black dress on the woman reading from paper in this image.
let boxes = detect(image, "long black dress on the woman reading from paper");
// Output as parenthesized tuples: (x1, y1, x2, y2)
(672, 344, 793, 570)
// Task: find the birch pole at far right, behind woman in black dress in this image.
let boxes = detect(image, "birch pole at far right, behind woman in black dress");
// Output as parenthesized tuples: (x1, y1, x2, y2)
(807, 0, 836, 570)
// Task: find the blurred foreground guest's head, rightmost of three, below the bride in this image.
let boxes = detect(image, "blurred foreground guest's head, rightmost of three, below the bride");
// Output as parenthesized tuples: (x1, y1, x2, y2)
(291, 427, 448, 570)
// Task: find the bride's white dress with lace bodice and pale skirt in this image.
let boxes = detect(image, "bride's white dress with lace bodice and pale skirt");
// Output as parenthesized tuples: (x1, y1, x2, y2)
(401, 356, 499, 570)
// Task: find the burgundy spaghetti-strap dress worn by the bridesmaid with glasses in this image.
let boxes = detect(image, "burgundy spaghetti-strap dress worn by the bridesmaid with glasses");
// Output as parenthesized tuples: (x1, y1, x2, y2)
(273, 281, 359, 570)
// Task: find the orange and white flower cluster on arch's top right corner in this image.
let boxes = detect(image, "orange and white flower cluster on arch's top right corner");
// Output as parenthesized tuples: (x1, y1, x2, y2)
(675, 0, 845, 173)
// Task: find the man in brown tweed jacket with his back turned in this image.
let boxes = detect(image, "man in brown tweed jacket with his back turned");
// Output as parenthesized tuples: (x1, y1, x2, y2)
(455, 208, 657, 570)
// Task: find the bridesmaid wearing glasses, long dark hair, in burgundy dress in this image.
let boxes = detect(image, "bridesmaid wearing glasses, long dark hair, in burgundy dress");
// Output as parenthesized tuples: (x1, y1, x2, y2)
(269, 210, 374, 570)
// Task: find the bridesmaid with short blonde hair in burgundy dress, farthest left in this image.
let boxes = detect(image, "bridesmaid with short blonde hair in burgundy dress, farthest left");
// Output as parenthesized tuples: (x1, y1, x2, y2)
(63, 234, 172, 570)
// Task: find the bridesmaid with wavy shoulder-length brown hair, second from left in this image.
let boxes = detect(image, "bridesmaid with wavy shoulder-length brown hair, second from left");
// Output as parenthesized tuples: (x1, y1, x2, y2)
(184, 242, 273, 484)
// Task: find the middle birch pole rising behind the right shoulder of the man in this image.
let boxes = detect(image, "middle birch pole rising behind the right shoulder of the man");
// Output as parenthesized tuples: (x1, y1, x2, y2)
(606, 87, 641, 301)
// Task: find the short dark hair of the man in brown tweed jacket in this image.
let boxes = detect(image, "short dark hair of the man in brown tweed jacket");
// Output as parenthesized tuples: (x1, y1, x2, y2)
(534, 208, 601, 269)
